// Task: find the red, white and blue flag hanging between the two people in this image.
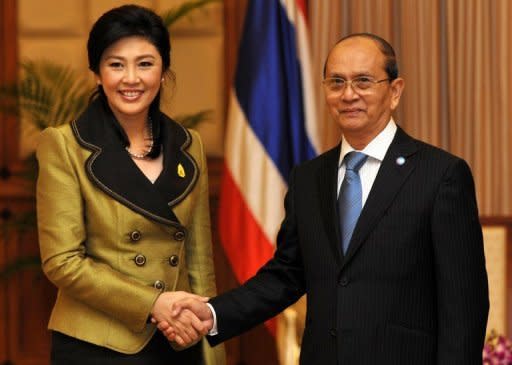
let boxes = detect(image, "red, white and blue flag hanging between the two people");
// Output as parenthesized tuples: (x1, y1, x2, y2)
(219, 0, 320, 330)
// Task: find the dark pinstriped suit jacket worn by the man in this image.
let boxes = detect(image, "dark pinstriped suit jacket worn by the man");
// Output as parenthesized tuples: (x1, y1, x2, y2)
(209, 128, 489, 365)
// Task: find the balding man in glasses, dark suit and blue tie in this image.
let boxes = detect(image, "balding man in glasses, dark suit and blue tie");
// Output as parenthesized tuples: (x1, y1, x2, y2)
(159, 33, 489, 365)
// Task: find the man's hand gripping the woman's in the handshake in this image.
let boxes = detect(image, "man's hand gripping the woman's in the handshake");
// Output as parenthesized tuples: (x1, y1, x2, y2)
(157, 296, 213, 347)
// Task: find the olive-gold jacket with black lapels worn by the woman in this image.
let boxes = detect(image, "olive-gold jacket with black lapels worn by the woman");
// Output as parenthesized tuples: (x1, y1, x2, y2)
(37, 101, 225, 365)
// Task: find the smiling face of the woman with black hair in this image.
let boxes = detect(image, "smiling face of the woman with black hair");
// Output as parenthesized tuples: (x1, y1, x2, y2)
(96, 36, 163, 123)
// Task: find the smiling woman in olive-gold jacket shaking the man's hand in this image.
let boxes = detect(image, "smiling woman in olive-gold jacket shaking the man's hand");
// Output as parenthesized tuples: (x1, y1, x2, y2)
(37, 5, 225, 365)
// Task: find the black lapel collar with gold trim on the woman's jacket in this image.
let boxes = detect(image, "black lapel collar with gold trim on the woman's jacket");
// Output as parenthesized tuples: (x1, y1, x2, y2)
(71, 99, 199, 226)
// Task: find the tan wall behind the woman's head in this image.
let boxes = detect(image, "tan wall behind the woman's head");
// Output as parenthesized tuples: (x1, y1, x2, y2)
(18, 0, 224, 155)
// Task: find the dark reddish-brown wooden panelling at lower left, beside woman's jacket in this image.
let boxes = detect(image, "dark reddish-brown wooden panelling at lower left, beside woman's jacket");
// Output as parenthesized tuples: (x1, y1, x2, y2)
(0, 193, 56, 365)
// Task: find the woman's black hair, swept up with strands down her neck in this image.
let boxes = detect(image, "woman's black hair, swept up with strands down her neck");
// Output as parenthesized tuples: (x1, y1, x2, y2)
(87, 5, 171, 158)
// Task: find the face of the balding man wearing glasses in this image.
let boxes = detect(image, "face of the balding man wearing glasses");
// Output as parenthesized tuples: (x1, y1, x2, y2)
(324, 37, 404, 148)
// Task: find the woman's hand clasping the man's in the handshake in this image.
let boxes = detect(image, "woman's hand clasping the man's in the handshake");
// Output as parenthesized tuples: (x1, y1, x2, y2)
(151, 291, 211, 347)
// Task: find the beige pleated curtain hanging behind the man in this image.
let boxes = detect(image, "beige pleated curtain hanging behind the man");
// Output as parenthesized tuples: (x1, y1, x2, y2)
(309, 0, 512, 216)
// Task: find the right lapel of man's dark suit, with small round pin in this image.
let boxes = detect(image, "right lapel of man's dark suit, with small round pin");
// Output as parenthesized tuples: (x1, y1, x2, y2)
(342, 128, 417, 267)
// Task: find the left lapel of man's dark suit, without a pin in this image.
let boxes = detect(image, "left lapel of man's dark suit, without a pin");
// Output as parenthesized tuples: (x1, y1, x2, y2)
(317, 145, 341, 265)
